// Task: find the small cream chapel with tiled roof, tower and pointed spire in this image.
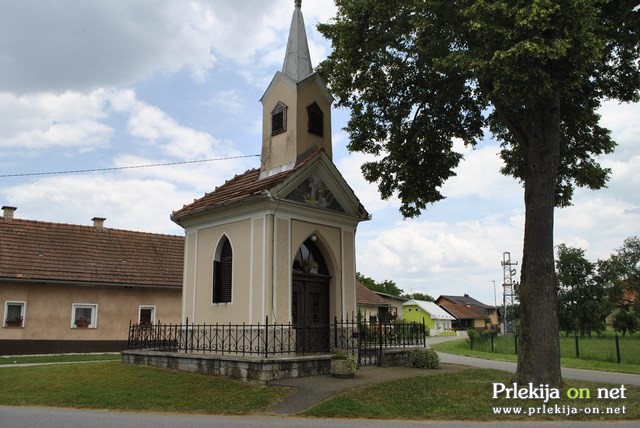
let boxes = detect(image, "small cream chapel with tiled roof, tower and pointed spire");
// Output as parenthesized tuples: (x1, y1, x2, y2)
(171, 1, 369, 351)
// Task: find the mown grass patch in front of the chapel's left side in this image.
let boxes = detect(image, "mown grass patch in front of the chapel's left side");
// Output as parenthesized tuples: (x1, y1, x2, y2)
(0, 361, 291, 415)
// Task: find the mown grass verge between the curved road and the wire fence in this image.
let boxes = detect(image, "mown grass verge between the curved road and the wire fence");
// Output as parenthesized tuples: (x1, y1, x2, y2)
(431, 337, 640, 374)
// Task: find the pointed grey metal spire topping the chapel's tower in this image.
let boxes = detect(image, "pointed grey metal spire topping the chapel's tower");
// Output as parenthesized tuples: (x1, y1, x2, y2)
(282, 0, 313, 82)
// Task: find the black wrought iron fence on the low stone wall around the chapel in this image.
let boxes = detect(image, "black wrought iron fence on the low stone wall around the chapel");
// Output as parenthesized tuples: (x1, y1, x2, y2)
(127, 317, 427, 364)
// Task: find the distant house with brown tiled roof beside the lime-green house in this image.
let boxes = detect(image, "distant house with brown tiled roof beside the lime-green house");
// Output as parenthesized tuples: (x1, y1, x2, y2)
(436, 294, 498, 330)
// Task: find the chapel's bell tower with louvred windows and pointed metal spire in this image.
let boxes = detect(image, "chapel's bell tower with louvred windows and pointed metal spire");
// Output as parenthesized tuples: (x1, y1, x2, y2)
(260, 0, 333, 178)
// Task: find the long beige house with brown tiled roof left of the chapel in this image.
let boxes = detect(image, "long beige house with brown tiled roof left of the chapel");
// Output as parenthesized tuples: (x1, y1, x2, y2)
(0, 206, 184, 355)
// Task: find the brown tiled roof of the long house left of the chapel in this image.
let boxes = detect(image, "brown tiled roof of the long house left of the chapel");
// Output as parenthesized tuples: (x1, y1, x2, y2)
(0, 217, 184, 287)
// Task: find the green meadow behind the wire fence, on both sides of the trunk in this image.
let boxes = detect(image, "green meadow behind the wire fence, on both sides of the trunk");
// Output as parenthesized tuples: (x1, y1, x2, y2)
(467, 332, 640, 365)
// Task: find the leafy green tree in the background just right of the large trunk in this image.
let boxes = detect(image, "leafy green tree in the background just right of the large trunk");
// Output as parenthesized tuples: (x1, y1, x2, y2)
(556, 244, 611, 336)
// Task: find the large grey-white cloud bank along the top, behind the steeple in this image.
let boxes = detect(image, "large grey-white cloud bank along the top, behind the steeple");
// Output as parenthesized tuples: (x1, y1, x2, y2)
(0, 0, 335, 93)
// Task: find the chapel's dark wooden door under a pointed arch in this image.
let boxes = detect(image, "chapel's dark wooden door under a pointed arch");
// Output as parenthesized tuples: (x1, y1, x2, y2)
(291, 236, 331, 352)
